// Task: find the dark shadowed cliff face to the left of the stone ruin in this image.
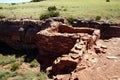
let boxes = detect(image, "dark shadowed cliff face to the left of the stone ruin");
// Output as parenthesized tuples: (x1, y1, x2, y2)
(0, 20, 40, 50)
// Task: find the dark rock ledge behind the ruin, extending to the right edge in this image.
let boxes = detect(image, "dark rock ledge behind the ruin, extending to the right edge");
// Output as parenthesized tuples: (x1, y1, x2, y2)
(72, 19, 120, 39)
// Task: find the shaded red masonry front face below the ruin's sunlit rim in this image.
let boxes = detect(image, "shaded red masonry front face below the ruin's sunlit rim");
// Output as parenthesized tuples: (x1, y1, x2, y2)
(37, 33, 76, 54)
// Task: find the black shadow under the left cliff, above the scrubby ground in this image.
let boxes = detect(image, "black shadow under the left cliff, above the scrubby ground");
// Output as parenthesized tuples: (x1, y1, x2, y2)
(0, 42, 38, 62)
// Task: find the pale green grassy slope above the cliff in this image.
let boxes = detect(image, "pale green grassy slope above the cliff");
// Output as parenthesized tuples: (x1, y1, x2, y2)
(0, 0, 120, 22)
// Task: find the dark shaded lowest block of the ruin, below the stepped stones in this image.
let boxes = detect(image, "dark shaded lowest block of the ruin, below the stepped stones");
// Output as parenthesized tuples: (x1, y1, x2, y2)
(51, 55, 78, 75)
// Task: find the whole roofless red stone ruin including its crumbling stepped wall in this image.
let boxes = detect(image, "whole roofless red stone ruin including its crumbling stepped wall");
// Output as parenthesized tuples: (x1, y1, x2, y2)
(36, 23, 100, 74)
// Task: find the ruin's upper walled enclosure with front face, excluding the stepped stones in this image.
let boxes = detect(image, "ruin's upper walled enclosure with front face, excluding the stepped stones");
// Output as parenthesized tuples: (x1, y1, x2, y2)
(36, 24, 94, 54)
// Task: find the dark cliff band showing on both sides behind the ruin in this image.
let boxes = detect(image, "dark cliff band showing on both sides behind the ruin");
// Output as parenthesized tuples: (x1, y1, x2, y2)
(0, 17, 120, 49)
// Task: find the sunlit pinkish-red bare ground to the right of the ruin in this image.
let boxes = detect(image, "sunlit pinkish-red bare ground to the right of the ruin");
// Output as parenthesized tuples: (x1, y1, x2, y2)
(54, 38, 120, 80)
